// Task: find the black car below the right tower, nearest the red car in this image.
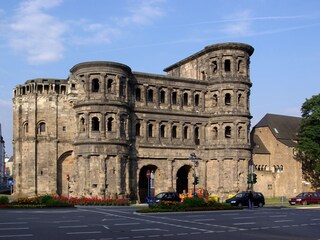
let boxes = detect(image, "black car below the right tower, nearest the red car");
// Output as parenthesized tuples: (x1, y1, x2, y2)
(226, 192, 265, 207)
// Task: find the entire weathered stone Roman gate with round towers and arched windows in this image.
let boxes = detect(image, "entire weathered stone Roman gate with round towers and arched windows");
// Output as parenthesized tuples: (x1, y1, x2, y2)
(13, 43, 253, 202)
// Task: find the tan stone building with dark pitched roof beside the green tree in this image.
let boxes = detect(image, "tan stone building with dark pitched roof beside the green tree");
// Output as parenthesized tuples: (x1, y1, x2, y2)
(251, 114, 310, 197)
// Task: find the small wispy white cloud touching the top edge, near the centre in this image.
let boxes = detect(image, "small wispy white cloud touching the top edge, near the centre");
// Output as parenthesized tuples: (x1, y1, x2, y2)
(118, 0, 165, 25)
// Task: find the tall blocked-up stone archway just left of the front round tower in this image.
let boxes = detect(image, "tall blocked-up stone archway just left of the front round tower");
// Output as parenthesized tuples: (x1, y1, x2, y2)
(57, 151, 74, 196)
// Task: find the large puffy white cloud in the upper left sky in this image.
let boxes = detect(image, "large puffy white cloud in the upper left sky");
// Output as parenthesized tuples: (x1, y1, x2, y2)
(9, 0, 67, 64)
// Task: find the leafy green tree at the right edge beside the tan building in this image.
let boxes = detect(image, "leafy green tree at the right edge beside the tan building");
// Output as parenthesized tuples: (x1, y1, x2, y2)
(297, 94, 320, 189)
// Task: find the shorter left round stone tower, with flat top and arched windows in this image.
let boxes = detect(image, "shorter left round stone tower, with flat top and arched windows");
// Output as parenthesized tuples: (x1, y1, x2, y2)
(69, 62, 131, 197)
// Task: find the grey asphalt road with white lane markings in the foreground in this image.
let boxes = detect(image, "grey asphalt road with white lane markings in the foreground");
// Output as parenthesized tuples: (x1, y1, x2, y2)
(0, 207, 320, 240)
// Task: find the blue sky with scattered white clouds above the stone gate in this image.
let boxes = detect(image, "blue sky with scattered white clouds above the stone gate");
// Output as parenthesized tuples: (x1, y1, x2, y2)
(0, 0, 320, 156)
